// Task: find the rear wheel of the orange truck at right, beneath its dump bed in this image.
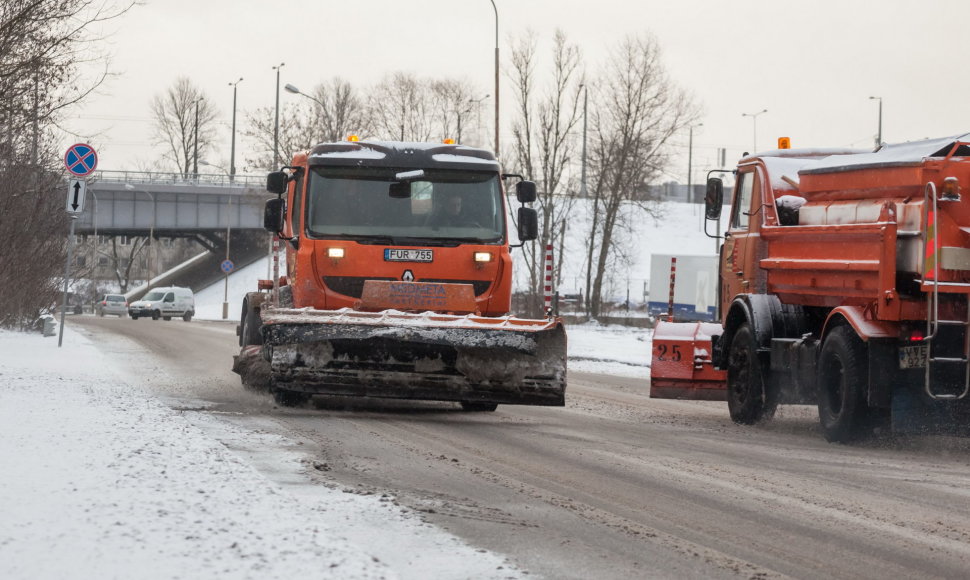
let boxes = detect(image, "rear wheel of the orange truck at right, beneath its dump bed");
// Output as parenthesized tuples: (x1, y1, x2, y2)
(818, 326, 869, 443)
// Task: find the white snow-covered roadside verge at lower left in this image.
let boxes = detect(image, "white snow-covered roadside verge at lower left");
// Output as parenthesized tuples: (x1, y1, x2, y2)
(0, 329, 520, 580)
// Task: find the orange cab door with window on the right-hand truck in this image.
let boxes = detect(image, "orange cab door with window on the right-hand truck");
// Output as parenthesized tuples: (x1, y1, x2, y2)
(721, 166, 762, 304)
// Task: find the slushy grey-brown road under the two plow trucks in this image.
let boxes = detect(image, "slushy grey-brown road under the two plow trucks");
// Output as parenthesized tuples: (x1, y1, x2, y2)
(72, 317, 970, 578)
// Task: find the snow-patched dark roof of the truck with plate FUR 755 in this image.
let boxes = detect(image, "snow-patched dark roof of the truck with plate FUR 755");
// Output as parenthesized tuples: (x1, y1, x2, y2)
(308, 141, 499, 171)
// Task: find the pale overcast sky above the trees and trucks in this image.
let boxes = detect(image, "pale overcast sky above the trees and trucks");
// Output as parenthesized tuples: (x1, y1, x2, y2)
(64, 0, 970, 183)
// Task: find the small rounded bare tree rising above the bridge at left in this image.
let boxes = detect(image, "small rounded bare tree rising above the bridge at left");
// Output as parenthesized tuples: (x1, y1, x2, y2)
(152, 77, 218, 177)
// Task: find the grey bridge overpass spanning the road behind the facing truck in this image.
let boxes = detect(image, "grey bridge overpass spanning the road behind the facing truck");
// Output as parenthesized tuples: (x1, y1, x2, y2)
(75, 171, 273, 290)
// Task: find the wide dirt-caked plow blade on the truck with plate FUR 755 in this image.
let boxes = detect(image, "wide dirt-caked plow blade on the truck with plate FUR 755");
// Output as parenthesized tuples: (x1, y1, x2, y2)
(234, 308, 566, 406)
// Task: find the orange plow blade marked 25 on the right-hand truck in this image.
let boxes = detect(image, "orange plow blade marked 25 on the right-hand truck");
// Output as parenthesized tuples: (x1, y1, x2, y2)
(650, 322, 727, 401)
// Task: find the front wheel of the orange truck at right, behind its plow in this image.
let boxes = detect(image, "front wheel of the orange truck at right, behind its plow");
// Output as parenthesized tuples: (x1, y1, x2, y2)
(727, 323, 778, 425)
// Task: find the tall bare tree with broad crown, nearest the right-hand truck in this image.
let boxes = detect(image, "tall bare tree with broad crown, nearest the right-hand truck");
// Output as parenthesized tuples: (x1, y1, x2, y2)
(589, 35, 698, 317)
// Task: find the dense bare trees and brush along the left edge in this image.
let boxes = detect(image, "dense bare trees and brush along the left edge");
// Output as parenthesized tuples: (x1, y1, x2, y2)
(0, 0, 130, 327)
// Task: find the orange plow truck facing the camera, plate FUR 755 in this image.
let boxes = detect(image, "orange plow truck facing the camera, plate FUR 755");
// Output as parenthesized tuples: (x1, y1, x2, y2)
(233, 141, 566, 411)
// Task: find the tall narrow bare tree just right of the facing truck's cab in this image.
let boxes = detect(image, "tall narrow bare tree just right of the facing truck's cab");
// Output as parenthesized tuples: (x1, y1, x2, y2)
(511, 30, 584, 316)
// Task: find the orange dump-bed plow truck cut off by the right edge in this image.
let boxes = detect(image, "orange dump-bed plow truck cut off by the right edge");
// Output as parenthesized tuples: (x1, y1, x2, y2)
(651, 135, 970, 442)
